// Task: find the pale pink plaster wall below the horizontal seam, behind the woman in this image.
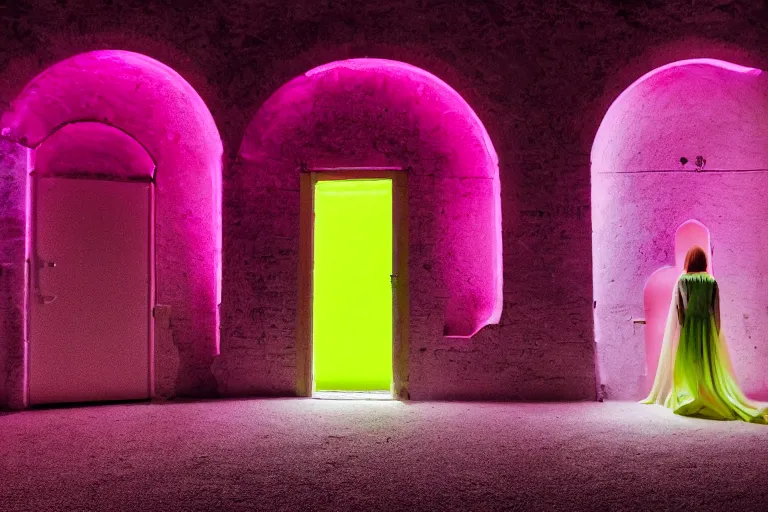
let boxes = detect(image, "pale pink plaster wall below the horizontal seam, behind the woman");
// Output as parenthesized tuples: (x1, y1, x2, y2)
(595, 173, 768, 399)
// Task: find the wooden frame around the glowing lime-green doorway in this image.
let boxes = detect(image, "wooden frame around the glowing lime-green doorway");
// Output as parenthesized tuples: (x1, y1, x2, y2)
(296, 168, 410, 399)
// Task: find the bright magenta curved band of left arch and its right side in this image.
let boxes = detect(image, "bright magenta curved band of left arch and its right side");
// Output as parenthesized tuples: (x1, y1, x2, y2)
(2, 52, 222, 406)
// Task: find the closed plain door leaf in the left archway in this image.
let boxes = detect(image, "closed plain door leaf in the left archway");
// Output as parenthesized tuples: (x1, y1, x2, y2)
(29, 178, 152, 404)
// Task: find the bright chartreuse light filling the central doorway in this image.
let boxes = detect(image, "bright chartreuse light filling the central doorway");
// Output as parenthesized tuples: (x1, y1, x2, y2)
(312, 179, 392, 391)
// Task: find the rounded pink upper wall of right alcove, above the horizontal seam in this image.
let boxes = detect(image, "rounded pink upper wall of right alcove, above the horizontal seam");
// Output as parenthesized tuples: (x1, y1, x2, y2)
(592, 61, 768, 173)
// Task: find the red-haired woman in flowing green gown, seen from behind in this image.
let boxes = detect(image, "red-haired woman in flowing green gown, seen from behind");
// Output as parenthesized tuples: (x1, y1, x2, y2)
(642, 247, 768, 424)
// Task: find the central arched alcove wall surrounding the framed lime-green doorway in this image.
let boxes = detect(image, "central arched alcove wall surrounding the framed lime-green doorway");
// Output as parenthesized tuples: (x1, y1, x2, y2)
(222, 59, 502, 394)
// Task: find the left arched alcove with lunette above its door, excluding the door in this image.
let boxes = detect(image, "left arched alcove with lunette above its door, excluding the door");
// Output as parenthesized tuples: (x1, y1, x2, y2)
(0, 50, 222, 405)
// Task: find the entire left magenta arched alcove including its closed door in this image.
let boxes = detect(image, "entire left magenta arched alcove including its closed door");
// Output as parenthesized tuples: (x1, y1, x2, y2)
(0, 50, 222, 408)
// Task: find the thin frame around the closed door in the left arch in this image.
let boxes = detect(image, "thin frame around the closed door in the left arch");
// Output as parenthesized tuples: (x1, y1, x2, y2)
(24, 173, 157, 405)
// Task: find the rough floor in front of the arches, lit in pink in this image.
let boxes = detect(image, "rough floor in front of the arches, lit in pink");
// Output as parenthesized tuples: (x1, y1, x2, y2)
(0, 399, 768, 512)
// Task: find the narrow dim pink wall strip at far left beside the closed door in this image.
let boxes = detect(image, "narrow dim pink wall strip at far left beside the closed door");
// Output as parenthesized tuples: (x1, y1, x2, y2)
(0, 137, 29, 409)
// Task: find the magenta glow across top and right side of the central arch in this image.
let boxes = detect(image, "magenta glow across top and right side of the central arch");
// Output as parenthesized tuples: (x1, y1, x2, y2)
(241, 59, 503, 338)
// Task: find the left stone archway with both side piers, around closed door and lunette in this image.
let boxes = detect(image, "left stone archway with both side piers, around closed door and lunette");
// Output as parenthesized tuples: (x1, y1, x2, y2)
(0, 50, 222, 407)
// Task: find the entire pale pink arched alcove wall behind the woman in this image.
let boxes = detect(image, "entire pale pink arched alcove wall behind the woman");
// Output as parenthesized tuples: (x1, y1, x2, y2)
(592, 59, 768, 399)
